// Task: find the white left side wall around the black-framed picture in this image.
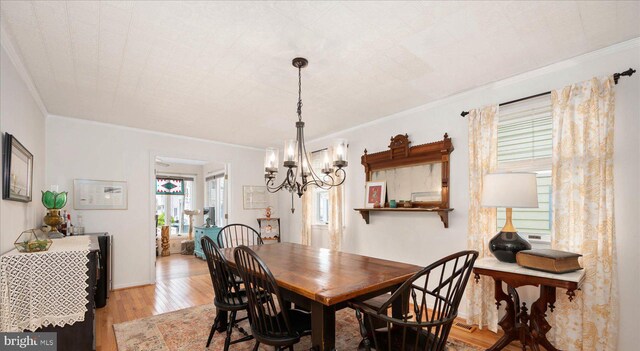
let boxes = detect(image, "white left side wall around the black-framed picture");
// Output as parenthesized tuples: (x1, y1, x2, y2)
(0, 46, 46, 254)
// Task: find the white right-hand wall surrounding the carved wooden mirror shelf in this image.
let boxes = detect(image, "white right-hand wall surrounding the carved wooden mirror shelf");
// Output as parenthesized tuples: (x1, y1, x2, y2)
(281, 39, 640, 350)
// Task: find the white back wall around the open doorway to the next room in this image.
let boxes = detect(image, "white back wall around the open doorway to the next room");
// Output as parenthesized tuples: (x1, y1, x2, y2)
(47, 116, 264, 288)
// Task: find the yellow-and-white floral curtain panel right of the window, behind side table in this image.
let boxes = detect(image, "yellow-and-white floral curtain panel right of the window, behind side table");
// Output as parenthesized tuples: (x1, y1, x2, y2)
(551, 77, 618, 351)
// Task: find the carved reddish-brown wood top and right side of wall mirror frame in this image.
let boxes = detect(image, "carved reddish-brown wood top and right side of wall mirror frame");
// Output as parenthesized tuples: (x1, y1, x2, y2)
(360, 133, 453, 209)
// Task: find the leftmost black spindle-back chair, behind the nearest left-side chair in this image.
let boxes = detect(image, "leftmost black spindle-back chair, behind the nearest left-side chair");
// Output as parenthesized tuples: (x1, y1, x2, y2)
(201, 236, 253, 351)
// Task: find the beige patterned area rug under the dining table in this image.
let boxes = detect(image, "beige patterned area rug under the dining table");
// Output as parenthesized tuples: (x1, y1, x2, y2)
(113, 304, 481, 351)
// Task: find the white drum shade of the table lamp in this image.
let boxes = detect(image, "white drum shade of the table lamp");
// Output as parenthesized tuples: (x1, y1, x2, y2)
(482, 172, 538, 208)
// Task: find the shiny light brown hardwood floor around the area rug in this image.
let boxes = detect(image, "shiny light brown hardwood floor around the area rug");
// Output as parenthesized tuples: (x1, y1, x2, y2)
(96, 255, 521, 351)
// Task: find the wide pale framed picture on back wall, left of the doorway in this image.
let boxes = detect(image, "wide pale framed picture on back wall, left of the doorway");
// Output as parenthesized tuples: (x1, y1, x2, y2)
(73, 179, 129, 210)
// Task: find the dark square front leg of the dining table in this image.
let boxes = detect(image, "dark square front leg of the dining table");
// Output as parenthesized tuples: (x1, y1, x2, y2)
(311, 301, 336, 351)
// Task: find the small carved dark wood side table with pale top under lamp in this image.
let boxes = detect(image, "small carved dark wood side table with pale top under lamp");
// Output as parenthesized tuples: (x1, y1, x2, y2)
(473, 257, 585, 351)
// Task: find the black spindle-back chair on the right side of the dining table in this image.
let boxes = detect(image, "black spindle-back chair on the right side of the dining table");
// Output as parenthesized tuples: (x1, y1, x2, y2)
(349, 251, 478, 351)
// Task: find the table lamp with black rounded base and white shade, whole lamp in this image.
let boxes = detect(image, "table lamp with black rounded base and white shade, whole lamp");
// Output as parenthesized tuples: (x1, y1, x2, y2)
(482, 172, 538, 263)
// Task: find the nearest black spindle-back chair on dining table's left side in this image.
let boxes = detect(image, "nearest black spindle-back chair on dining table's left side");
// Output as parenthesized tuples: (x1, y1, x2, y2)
(233, 245, 311, 351)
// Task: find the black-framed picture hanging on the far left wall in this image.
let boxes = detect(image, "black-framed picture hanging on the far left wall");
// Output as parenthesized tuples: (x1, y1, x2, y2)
(2, 133, 33, 202)
